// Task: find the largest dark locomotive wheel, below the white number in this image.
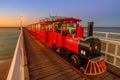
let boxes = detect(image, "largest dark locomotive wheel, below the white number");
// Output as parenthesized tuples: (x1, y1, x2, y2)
(70, 54, 81, 68)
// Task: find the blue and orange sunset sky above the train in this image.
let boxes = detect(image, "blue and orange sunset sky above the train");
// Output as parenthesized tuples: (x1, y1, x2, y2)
(0, 0, 120, 27)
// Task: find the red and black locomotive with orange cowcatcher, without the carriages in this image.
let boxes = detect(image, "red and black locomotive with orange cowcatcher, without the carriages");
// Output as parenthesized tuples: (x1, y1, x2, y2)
(53, 18, 106, 75)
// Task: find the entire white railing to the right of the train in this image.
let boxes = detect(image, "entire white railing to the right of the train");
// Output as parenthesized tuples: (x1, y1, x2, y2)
(84, 31, 120, 68)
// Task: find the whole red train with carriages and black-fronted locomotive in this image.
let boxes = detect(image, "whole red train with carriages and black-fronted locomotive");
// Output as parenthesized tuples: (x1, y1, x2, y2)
(27, 17, 106, 75)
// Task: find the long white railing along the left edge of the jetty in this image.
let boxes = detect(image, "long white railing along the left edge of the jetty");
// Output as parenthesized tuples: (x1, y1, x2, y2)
(7, 29, 24, 80)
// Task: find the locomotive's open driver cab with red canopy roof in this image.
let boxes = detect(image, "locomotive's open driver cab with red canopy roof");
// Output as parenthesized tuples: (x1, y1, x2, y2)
(55, 18, 81, 35)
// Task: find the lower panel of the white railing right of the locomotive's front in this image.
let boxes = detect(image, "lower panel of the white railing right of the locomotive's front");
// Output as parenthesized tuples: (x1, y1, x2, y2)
(101, 39, 120, 68)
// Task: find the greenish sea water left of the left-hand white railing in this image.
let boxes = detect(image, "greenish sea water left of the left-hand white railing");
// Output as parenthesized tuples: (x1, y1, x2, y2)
(0, 28, 20, 60)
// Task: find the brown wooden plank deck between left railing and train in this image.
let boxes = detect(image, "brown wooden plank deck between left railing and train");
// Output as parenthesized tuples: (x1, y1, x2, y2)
(24, 31, 88, 80)
